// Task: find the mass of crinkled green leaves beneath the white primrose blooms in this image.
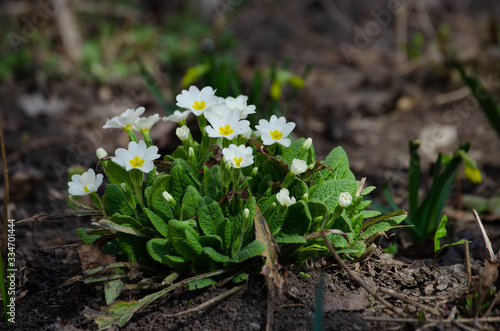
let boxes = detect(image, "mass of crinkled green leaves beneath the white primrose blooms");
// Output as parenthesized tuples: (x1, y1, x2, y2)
(75, 85, 406, 324)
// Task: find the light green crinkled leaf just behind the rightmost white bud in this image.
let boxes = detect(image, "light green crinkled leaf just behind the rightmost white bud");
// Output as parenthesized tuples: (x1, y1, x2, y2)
(309, 179, 357, 213)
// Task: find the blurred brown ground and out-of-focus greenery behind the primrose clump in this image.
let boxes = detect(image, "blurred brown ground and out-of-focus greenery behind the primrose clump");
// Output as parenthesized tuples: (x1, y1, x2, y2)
(0, 0, 500, 249)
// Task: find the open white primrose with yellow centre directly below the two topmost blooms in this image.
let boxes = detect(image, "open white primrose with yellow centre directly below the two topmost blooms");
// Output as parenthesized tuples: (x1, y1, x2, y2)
(205, 110, 250, 140)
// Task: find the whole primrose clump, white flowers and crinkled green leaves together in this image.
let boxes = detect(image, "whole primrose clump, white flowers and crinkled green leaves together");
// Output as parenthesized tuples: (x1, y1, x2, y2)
(68, 86, 404, 274)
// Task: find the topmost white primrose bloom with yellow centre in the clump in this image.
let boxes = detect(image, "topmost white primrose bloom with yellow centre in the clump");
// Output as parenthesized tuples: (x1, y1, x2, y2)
(175, 85, 218, 116)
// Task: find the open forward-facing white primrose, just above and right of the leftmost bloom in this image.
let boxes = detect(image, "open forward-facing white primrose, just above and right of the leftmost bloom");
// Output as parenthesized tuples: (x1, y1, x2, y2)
(112, 140, 161, 173)
